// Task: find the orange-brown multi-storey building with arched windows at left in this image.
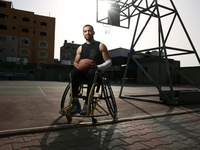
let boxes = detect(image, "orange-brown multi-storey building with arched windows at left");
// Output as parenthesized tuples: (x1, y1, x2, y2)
(0, 1, 55, 66)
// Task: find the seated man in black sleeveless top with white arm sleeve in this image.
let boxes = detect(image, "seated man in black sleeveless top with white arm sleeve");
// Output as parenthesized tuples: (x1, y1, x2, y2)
(70, 25, 112, 115)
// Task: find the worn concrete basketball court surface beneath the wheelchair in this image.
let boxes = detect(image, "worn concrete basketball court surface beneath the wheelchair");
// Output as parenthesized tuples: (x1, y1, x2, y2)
(0, 81, 200, 135)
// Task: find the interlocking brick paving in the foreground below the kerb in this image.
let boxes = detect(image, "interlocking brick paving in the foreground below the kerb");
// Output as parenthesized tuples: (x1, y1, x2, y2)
(0, 113, 200, 150)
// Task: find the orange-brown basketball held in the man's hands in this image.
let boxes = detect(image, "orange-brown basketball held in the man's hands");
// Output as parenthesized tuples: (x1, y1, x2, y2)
(77, 59, 96, 72)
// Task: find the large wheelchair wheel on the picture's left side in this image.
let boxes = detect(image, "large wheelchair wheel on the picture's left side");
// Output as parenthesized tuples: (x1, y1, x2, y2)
(60, 83, 72, 122)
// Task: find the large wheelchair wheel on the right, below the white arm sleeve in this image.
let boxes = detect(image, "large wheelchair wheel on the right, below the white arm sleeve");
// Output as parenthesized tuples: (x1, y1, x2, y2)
(103, 78, 117, 119)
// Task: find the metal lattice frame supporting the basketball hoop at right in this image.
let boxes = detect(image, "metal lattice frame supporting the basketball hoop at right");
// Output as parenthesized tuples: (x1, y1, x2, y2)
(97, 0, 200, 104)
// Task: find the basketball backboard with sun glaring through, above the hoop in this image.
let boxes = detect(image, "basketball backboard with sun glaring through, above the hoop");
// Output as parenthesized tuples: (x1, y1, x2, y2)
(97, 0, 130, 28)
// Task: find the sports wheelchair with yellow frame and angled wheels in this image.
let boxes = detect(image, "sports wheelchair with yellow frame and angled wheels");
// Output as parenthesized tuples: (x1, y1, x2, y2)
(59, 70, 117, 124)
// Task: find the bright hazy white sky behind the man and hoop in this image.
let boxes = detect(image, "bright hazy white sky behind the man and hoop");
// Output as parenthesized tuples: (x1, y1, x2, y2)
(6, 0, 200, 67)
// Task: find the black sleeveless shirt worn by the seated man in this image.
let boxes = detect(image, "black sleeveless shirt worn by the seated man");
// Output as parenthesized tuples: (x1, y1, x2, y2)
(81, 41, 104, 65)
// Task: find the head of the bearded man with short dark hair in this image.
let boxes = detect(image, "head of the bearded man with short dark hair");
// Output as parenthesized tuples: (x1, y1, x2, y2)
(83, 24, 95, 42)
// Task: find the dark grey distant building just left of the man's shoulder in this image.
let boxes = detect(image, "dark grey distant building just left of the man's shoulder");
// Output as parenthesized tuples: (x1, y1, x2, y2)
(60, 40, 80, 65)
